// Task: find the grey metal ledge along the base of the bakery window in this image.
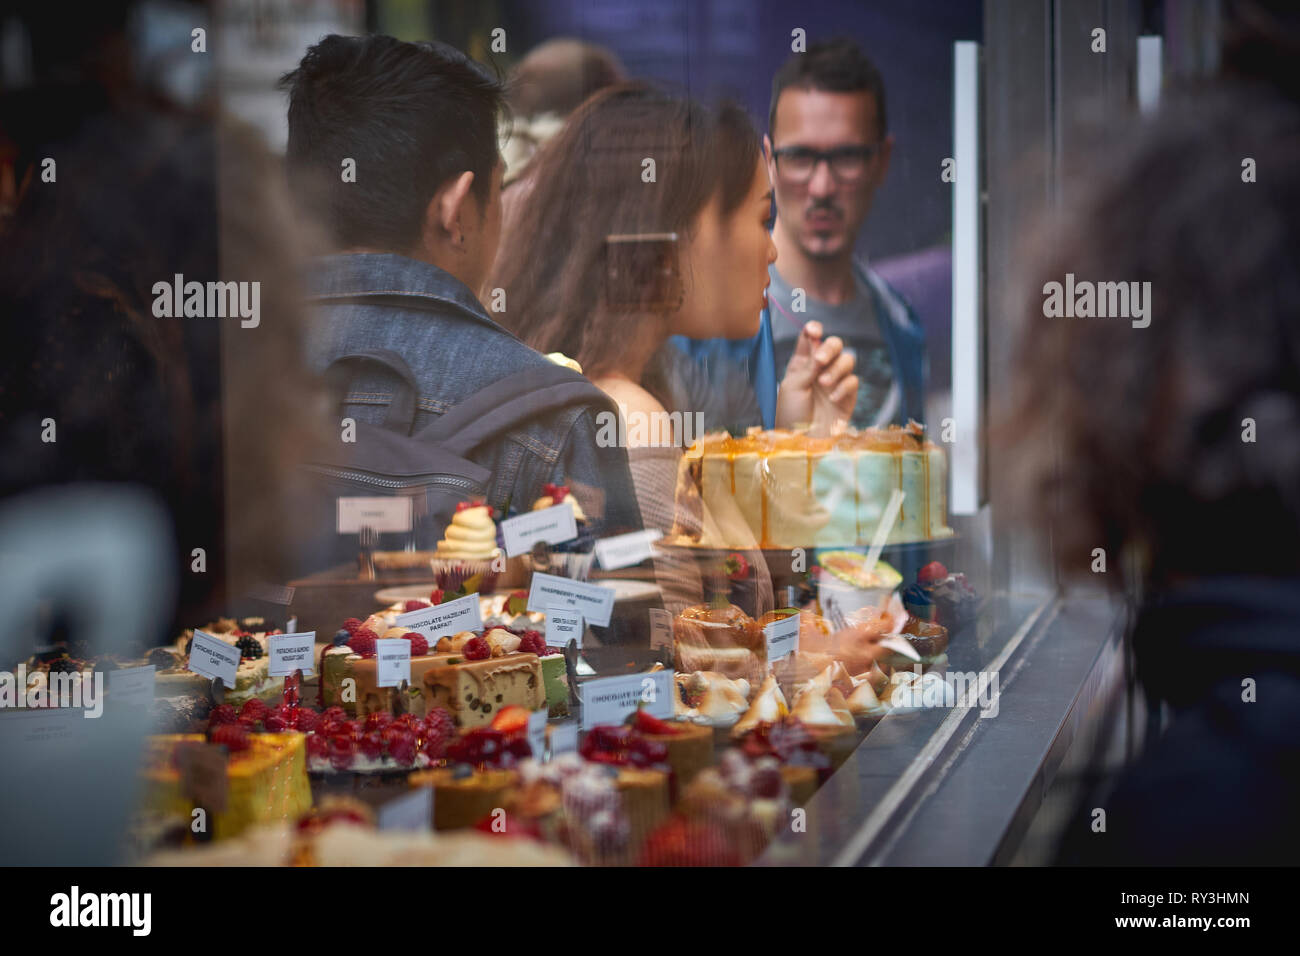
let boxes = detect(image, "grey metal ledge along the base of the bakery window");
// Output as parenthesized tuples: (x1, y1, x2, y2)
(759, 594, 1123, 866)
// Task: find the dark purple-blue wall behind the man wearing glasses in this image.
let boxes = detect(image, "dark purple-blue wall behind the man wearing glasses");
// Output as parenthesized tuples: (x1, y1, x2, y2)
(421, 0, 983, 259)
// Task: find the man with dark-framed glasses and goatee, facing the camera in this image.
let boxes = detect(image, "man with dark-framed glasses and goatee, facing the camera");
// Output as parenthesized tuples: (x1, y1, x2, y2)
(677, 40, 926, 428)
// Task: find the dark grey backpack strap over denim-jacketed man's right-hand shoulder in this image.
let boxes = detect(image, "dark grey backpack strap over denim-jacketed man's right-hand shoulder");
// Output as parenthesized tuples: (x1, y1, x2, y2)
(417, 364, 616, 458)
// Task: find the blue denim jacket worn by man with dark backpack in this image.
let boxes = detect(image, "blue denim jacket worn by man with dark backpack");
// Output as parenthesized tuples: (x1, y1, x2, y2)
(307, 254, 641, 535)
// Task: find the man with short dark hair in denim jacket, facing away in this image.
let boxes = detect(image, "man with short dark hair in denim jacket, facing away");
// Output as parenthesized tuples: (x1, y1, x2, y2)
(282, 36, 640, 533)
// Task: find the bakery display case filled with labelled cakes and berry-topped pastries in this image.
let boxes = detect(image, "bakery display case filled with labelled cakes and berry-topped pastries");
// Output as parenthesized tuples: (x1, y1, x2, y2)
(0, 3, 1170, 866)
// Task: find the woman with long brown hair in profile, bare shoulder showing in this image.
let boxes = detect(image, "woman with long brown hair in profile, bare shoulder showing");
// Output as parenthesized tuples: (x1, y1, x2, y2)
(490, 83, 776, 606)
